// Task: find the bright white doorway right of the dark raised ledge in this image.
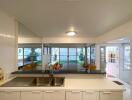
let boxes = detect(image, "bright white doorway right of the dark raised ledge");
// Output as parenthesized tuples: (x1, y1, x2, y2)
(100, 45, 119, 77)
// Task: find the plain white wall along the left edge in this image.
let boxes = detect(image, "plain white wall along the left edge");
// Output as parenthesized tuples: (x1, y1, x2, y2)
(0, 11, 17, 77)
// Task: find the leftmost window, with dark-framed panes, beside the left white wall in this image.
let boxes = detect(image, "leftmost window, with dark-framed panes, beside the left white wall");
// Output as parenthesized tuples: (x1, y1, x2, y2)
(18, 45, 42, 69)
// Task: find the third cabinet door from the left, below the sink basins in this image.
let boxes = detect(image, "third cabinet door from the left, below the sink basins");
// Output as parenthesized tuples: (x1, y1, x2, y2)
(43, 90, 65, 100)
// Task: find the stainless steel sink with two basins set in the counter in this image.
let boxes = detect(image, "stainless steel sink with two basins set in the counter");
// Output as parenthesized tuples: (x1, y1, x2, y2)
(30, 77, 65, 87)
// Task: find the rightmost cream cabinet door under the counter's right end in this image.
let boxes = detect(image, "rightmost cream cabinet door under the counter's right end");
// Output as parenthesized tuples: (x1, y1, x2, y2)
(100, 92, 123, 100)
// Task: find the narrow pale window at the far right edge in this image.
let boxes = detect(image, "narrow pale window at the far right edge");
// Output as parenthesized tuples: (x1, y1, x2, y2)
(124, 44, 130, 70)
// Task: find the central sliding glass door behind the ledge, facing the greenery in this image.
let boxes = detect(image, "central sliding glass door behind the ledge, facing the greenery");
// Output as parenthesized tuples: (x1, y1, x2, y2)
(51, 47, 83, 71)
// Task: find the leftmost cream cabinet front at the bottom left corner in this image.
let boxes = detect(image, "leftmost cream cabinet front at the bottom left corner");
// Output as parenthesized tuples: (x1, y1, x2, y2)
(0, 91, 20, 100)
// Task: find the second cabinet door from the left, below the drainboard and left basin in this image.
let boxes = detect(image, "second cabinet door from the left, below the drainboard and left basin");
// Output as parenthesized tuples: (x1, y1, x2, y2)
(21, 91, 43, 100)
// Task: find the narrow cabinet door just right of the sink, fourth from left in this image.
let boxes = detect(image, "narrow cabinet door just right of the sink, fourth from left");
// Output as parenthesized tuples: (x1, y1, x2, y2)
(66, 91, 83, 100)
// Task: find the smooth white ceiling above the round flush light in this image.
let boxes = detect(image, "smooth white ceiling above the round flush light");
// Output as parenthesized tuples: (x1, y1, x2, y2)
(0, 0, 132, 37)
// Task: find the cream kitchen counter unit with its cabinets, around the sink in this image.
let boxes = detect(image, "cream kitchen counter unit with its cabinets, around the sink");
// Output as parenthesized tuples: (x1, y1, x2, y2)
(0, 77, 125, 100)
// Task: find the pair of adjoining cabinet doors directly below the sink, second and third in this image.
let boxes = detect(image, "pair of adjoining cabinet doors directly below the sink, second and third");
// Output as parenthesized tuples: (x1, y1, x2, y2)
(20, 90, 65, 100)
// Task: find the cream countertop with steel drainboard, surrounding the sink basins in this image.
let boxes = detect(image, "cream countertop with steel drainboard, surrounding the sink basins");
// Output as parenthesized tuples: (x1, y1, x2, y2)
(0, 77, 125, 91)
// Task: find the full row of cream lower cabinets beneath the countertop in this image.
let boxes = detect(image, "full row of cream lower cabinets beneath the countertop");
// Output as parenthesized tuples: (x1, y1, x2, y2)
(0, 90, 123, 100)
